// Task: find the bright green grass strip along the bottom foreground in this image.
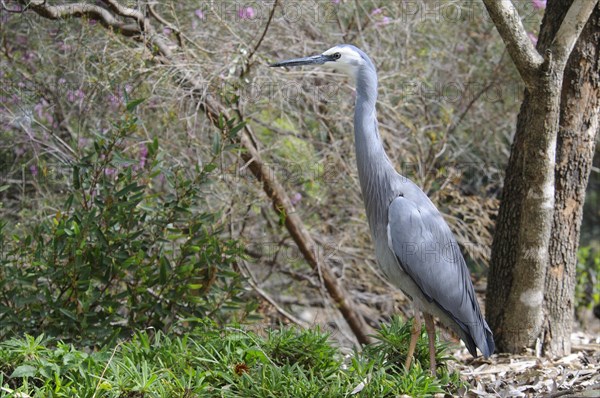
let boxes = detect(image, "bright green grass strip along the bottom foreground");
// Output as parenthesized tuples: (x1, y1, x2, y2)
(0, 319, 463, 397)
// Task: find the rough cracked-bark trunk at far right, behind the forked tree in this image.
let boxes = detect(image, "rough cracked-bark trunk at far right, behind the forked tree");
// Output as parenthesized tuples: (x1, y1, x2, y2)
(542, 7, 600, 356)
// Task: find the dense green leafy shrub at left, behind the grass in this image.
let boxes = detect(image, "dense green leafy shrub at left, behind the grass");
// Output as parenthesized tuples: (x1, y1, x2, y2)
(0, 107, 255, 346)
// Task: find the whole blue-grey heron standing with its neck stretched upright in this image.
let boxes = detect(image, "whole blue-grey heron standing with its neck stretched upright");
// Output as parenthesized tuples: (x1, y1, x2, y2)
(270, 44, 494, 371)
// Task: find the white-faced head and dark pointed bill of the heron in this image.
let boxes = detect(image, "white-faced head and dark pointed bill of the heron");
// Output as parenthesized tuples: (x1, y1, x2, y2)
(269, 44, 375, 79)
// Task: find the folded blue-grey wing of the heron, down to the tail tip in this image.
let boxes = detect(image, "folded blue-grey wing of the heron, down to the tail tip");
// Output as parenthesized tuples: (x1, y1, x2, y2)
(388, 194, 494, 357)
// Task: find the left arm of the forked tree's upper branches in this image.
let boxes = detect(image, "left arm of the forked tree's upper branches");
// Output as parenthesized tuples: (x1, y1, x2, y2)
(483, 0, 544, 87)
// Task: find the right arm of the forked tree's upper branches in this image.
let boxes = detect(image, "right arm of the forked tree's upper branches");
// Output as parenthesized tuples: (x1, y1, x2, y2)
(550, 0, 598, 70)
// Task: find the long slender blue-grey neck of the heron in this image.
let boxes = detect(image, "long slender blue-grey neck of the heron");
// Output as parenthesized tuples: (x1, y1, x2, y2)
(354, 67, 396, 224)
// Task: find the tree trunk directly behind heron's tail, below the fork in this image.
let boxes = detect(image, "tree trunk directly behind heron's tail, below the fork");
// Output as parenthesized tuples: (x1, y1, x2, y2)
(486, 81, 560, 352)
